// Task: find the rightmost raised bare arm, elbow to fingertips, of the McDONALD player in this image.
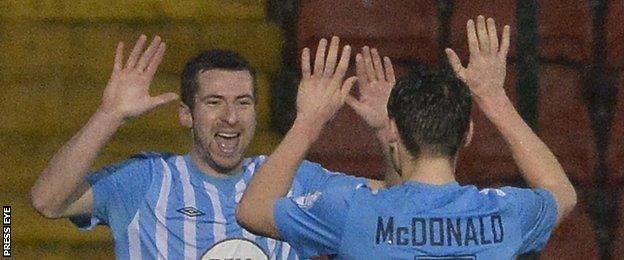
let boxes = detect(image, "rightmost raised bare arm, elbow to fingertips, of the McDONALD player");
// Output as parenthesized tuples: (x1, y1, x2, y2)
(446, 16, 576, 222)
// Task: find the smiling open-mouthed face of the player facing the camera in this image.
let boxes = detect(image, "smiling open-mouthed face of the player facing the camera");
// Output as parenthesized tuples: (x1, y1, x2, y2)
(180, 69, 256, 175)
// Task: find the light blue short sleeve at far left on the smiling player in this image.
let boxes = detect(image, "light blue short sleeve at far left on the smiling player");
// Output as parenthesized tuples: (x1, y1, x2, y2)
(71, 153, 157, 230)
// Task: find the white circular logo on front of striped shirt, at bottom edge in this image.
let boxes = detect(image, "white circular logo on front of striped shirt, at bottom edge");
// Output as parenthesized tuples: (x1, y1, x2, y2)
(201, 238, 269, 260)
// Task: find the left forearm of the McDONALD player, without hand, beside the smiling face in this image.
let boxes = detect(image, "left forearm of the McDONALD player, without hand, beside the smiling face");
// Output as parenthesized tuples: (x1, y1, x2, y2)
(237, 119, 321, 238)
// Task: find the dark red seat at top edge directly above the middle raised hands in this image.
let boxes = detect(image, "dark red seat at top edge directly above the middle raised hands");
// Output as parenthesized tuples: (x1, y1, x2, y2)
(297, 0, 439, 64)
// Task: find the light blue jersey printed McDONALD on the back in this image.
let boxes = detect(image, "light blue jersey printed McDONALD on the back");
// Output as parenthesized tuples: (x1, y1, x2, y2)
(275, 182, 557, 260)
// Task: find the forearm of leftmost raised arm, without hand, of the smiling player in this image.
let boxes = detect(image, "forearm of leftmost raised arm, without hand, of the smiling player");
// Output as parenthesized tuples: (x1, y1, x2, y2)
(31, 108, 121, 218)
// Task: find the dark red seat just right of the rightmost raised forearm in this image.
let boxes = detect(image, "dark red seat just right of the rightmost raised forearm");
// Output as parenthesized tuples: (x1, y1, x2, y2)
(538, 65, 597, 186)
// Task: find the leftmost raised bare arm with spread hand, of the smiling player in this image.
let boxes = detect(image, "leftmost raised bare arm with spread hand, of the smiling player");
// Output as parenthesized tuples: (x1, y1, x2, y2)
(31, 36, 177, 218)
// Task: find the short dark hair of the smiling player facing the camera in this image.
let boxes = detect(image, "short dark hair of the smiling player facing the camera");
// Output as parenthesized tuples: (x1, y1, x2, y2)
(180, 49, 258, 109)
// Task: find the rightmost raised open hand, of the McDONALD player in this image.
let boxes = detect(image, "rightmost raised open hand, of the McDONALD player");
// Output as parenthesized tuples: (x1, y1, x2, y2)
(446, 16, 509, 101)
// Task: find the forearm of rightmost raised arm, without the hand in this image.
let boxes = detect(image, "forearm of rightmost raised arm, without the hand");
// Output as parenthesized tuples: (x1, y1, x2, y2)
(479, 96, 576, 214)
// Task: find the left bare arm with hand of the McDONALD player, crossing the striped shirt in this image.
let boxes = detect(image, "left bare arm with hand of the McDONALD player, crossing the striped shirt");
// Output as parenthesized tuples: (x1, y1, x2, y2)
(236, 37, 356, 239)
